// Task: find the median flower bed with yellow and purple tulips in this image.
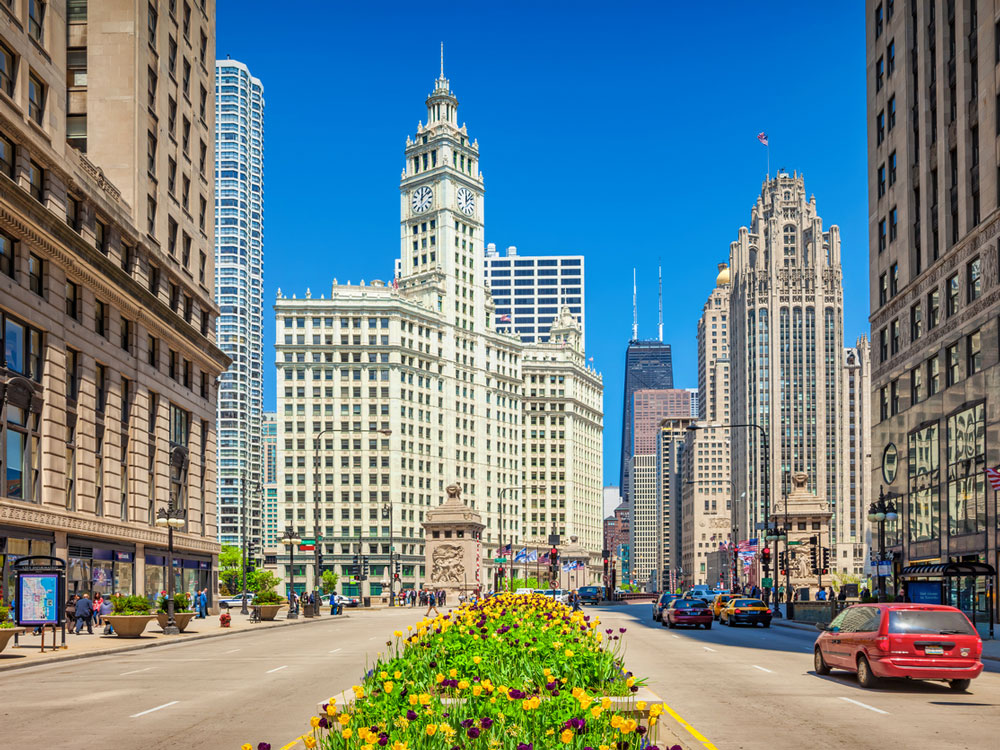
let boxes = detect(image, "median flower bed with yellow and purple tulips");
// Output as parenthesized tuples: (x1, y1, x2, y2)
(243, 594, 680, 750)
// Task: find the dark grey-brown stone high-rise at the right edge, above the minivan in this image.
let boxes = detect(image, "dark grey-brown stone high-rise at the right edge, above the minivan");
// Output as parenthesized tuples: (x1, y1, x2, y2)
(865, 0, 1000, 619)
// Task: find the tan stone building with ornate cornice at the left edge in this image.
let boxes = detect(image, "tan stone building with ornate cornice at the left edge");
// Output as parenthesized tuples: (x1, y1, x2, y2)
(0, 2, 229, 601)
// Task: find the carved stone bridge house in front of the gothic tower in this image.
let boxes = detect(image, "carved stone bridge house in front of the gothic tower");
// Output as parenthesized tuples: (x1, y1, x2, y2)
(771, 472, 836, 599)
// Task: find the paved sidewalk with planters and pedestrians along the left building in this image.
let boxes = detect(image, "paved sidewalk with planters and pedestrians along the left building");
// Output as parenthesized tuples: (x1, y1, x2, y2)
(0, 610, 348, 672)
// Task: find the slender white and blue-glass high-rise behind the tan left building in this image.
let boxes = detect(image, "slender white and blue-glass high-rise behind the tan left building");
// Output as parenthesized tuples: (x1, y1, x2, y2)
(214, 60, 264, 548)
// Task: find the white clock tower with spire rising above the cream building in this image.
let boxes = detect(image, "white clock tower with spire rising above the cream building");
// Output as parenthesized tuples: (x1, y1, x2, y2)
(399, 52, 486, 331)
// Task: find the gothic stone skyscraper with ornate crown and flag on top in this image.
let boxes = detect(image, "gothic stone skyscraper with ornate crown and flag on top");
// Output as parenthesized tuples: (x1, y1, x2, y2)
(729, 172, 846, 542)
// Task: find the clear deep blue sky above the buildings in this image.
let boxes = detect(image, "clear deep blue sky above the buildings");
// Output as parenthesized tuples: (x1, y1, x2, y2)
(216, 0, 868, 484)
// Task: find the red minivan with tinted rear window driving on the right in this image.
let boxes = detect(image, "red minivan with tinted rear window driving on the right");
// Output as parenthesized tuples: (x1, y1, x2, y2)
(813, 604, 983, 690)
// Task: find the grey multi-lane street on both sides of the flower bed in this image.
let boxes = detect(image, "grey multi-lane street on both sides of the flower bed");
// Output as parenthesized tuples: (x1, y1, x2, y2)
(0, 604, 1000, 750)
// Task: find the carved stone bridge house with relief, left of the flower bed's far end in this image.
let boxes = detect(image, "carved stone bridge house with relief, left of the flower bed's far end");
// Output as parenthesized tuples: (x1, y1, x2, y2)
(422, 484, 488, 602)
